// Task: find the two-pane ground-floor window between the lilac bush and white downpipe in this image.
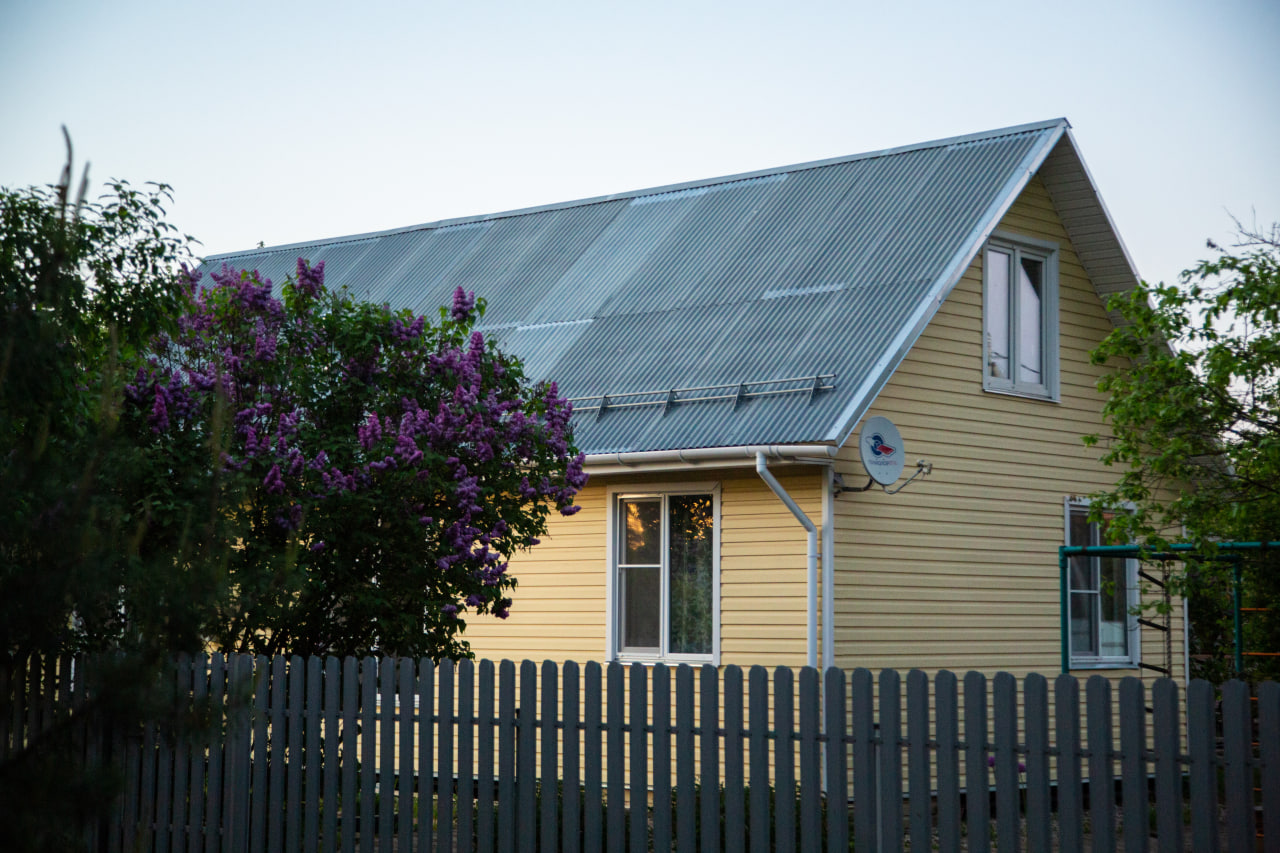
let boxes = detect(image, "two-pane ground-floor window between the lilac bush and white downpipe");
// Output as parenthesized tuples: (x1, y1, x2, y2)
(611, 488, 719, 661)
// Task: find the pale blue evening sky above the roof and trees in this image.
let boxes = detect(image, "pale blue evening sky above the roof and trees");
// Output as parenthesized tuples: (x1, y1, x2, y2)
(0, 0, 1280, 289)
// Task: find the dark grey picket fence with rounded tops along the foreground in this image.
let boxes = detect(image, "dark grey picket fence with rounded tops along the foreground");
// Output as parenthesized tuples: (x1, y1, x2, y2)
(0, 654, 1280, 853)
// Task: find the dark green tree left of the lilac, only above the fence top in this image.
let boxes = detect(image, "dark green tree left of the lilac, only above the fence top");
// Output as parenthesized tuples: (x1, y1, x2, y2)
(0, 159, 198, 657)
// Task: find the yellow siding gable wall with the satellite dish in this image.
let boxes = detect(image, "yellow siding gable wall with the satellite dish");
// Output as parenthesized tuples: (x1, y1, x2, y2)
(836, 178, 1184, 678)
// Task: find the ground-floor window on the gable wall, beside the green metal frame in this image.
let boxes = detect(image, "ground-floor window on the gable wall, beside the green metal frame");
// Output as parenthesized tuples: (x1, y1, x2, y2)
(1066, 502, 1139, 667)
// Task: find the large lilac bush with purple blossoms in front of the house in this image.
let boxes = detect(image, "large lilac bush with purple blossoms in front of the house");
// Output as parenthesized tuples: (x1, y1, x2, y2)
(124, 259, 586, 658)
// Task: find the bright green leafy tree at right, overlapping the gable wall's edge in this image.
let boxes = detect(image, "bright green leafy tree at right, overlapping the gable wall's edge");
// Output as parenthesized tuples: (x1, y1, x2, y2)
(1085, 227, 1280, 676)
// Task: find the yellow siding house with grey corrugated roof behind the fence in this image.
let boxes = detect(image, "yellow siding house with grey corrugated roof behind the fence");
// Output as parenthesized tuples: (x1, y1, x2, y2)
(207, 119, 1185, 678)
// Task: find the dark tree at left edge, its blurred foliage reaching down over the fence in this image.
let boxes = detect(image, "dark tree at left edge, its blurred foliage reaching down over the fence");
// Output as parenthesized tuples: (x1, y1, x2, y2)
(0, 143, 210, 849)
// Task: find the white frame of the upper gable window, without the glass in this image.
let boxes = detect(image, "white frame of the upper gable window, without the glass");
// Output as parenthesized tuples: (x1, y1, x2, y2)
(982, 231, 1061, 402)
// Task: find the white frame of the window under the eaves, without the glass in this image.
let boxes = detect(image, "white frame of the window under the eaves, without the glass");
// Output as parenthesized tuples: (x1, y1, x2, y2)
(604, 482, 721, 666)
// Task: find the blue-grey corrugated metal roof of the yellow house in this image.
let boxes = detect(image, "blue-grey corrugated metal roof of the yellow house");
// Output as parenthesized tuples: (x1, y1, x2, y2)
(206, 119, 1123, 453)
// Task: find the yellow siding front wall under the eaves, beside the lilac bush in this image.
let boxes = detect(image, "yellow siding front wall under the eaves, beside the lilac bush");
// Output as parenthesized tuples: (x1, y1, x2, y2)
(463, 466, 822, 666)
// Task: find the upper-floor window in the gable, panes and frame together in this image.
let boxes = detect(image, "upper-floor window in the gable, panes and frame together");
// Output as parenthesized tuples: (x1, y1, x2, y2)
(983, 230, 1059, 400)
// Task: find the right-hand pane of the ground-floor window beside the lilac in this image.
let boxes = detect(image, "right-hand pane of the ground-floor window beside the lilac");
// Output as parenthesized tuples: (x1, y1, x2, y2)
(668, 494, 714, 654)
